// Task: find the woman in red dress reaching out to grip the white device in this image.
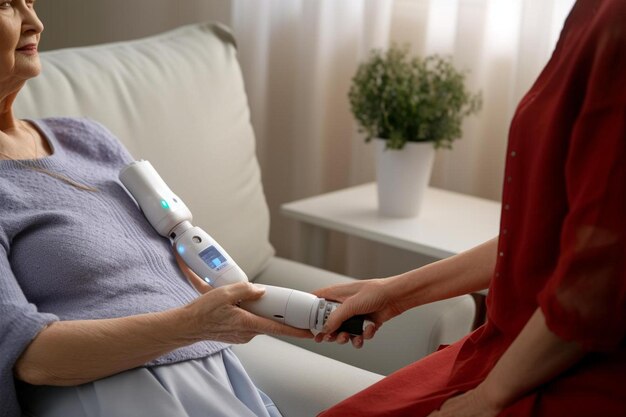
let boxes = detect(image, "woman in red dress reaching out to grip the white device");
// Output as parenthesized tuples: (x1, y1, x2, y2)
(316, 0, 626, 417)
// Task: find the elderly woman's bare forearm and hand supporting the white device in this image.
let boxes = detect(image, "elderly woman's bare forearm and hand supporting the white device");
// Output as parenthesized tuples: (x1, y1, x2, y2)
(14, 283, 310, 386)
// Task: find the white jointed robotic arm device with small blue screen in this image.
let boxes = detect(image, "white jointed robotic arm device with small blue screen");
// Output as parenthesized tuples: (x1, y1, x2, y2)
(119, 160, 371, 334)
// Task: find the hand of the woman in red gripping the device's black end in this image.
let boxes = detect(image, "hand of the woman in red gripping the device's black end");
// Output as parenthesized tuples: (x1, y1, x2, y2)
(314, 278, 404, 348)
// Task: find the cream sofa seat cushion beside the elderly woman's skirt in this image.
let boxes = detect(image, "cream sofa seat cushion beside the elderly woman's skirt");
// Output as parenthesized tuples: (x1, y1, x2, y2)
(233, 336, 383, 417)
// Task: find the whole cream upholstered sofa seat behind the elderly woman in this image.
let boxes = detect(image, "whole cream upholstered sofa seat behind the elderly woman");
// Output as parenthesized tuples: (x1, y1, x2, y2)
(15, 23, 474, 417)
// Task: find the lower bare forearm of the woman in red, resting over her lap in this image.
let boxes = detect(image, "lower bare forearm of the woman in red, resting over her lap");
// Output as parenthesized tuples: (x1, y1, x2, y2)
(480, 308, 585, 409)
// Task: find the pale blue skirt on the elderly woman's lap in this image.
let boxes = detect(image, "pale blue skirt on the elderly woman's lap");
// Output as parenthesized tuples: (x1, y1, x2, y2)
(19, 349, 281, 417)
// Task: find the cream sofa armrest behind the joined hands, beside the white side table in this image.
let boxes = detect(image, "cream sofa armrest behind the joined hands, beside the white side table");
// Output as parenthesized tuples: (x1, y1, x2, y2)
(254, 257, 476, 375)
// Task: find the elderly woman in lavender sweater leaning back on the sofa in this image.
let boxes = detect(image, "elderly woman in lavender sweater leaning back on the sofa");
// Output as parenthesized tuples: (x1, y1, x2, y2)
(0, 0, 310, 417)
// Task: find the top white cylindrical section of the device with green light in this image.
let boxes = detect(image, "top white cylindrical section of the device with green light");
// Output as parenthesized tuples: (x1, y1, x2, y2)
(119, 160, 192, 237)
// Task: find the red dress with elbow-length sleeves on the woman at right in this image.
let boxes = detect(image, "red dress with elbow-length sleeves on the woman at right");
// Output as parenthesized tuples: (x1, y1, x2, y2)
(320, 0, 626, 417)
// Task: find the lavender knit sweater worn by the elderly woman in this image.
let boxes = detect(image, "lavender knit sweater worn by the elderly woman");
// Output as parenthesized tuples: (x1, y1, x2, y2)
(0, 118, 225, 417)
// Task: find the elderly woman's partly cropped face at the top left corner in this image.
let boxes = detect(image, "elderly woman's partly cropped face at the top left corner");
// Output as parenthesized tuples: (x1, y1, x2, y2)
(0, 0, 43, 85)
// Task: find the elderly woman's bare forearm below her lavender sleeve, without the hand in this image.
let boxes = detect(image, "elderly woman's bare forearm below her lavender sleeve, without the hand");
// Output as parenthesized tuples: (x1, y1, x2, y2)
(14, 308, 197, 385)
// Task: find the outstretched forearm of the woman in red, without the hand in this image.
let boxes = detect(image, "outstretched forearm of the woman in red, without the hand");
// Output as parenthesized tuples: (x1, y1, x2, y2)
(389, 238, 498, 309)
